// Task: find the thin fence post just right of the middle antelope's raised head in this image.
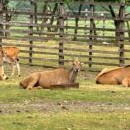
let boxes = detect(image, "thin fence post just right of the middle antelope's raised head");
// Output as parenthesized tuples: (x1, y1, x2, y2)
(88, 4, 94, 68)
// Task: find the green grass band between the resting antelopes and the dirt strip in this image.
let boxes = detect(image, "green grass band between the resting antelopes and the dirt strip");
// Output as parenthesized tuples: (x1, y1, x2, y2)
(0, 79, 130, 105)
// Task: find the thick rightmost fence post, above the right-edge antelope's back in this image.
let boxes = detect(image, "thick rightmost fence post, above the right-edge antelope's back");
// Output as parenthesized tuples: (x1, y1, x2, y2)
(118, 3, 125, 66)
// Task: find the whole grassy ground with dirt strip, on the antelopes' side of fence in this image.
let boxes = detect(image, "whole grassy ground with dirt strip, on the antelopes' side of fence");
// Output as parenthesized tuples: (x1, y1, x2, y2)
(0, 65, 130, 130)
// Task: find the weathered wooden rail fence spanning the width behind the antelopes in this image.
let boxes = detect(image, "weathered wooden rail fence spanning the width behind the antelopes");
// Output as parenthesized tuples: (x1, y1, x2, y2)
(0, 0, 130, 71)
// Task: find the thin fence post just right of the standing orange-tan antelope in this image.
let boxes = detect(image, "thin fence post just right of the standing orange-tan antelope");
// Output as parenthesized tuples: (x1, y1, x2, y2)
(29, 1, 33, 64)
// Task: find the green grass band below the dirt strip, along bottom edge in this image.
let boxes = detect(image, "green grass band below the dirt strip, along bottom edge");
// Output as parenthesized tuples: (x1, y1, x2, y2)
(0, 112, 130, 130)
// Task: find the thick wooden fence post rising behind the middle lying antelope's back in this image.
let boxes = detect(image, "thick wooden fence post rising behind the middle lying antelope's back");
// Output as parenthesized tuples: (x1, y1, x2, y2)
(59, 1, 65, 66)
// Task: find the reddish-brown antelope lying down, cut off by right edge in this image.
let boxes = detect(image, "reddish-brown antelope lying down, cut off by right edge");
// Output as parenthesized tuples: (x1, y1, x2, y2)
(96, 65, 130, 86)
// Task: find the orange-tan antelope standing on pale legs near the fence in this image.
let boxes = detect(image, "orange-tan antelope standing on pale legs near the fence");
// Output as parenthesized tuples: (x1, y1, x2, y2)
(0, 46, 20, 76)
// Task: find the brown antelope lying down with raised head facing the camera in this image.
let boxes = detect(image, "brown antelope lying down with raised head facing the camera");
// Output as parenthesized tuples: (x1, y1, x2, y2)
(20, 60, 81, 89)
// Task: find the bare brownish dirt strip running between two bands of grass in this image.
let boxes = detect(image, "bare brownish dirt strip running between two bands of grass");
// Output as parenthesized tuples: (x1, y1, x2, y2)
(0, 101, 130, 114)
